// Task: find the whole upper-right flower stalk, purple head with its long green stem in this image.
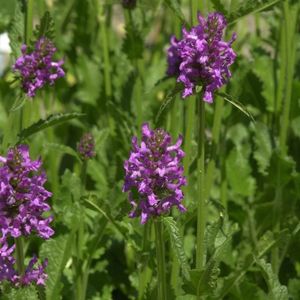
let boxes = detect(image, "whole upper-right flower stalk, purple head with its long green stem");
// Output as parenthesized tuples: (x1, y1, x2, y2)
(167, 13, 236, 269)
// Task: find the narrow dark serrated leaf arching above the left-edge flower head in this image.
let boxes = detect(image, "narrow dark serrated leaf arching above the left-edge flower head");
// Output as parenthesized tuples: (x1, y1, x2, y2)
(18, 112, 85, 142)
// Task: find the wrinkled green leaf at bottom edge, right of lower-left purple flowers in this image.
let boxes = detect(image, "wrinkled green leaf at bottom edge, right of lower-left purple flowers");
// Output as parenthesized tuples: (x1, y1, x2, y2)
(40, 233, 73, 300)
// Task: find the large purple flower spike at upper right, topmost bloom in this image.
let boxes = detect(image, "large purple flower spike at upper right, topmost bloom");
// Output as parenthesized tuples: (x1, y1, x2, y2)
(167, 12, 236, 103)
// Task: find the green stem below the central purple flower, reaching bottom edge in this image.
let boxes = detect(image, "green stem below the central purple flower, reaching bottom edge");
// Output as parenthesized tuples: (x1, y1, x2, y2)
(154, 218, 167, 300)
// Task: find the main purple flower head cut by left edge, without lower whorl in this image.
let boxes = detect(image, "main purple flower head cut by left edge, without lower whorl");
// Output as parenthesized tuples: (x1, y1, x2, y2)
(0, 145, 54, 239)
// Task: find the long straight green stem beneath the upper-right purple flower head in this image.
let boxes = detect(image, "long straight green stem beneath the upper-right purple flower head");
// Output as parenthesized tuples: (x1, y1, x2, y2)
(196, 97, 206, 269)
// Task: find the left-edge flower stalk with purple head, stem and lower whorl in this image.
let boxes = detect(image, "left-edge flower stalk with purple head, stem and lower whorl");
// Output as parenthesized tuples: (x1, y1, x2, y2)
(0, 145, 54, 286)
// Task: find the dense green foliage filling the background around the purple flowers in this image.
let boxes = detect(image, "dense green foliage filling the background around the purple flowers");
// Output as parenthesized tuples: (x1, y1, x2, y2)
(0, 0, 300, 300)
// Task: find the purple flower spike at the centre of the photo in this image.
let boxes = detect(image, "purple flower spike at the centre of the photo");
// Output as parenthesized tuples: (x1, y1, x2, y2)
(123, 123, 186, 224)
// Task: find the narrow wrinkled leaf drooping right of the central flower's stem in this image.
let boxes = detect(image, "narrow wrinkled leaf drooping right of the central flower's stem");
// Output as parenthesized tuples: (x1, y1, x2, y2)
(163, 217, 190, 280)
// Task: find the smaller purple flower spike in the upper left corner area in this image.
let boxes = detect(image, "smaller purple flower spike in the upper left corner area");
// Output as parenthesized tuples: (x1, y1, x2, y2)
(13, 37, 65, 98)
